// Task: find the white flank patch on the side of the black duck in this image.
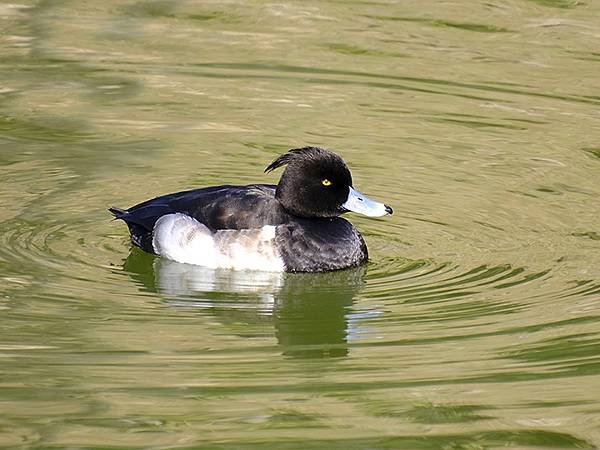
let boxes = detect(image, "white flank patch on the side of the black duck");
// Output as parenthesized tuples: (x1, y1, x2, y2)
(152, 213, 284, 272)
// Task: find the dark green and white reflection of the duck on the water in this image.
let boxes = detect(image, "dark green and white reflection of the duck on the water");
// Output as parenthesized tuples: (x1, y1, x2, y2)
(123, 249, 365, 358)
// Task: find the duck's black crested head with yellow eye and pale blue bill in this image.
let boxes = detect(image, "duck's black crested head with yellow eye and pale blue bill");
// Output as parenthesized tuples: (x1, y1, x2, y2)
(265, 147, 392, 217)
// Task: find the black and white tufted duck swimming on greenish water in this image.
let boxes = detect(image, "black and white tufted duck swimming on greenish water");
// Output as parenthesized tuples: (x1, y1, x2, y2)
(109, 147, 393, 272)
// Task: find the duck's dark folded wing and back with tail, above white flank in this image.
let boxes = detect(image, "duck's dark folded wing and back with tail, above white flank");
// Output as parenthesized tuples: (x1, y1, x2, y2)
(109, 184, 287, 252)
